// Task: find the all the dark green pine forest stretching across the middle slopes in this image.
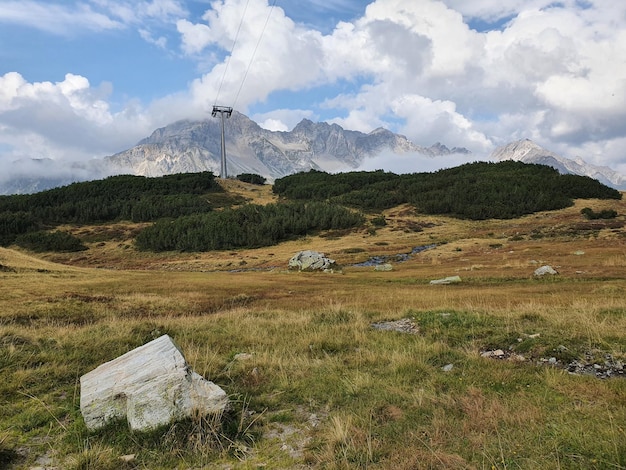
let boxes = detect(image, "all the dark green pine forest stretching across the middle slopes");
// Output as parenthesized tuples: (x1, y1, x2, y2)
(0, 161, 621, 251)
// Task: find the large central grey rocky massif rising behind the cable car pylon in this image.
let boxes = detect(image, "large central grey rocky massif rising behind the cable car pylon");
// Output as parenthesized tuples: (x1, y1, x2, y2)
(105, 112, 470, 180)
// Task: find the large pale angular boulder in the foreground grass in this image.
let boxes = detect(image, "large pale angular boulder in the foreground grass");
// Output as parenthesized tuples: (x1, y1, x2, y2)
(80, 335, 228, 431)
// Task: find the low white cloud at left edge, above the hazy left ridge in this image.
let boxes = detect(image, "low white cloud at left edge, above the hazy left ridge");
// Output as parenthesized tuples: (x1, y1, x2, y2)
(0, 72, 158, 160)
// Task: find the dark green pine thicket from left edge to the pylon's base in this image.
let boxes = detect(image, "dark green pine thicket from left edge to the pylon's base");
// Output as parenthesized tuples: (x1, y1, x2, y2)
(0, 172, 224, 246)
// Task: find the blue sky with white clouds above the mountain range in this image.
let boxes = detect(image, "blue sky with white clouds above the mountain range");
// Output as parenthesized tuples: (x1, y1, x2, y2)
(0, 0, 626, 178)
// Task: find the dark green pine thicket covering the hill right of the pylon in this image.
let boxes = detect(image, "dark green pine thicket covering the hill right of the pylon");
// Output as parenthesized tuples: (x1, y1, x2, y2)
(273, 161, 621, 220)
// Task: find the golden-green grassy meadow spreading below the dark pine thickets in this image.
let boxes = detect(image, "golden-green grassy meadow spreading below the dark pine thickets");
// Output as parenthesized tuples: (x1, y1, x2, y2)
(0, 181, 626, 470)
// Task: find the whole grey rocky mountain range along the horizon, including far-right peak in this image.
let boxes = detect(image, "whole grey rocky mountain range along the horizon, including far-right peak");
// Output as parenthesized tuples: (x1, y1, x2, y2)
(0, 111, 626, 194)
